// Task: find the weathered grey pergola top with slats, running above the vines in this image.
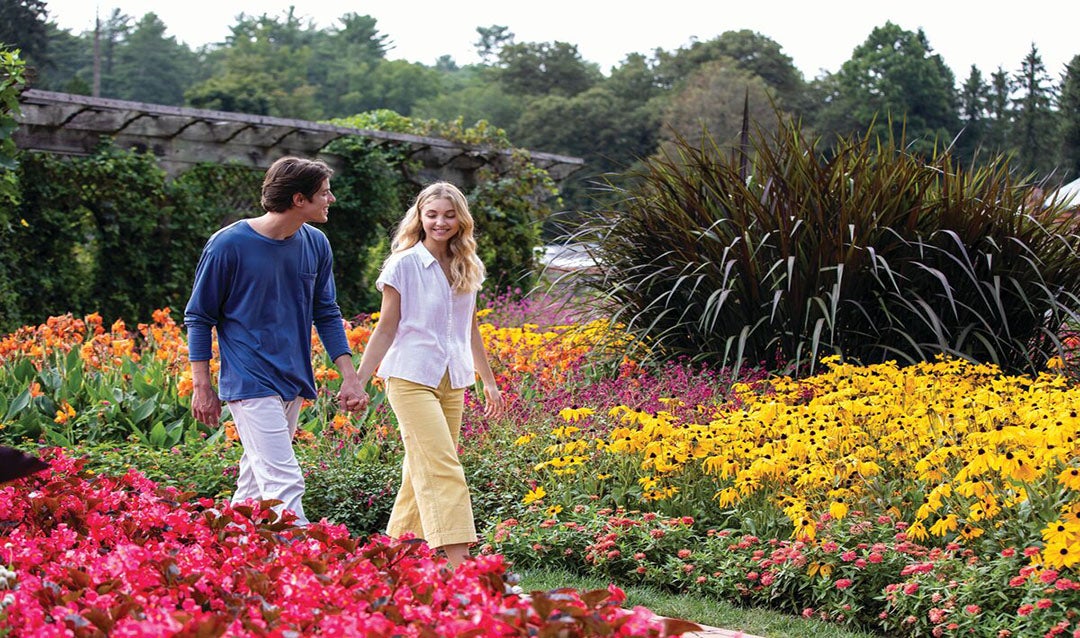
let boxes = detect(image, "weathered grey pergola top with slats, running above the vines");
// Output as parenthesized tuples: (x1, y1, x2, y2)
(14, 89, 584, 186)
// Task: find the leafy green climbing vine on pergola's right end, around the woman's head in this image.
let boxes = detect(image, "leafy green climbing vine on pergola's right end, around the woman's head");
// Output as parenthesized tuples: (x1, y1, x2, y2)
(326, 110, 557, 302)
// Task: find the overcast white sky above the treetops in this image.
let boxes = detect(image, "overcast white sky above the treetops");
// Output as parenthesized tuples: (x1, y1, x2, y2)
(46, 0, 1080, 82)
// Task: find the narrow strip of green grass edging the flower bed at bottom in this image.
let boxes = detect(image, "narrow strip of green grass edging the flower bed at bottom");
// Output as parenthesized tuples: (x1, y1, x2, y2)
(519, 570, 878, 638)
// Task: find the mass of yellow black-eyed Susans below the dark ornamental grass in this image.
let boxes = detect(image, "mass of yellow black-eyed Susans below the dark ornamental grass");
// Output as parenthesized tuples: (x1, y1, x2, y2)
(537, 358, 1080, 568)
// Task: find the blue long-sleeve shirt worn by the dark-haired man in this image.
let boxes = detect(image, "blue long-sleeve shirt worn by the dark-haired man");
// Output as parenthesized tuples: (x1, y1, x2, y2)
(184, 221, 351, 401)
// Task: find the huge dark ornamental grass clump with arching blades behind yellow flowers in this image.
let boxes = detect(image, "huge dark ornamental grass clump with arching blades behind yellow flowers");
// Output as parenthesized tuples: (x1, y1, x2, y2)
(575, 116, 1080, 371)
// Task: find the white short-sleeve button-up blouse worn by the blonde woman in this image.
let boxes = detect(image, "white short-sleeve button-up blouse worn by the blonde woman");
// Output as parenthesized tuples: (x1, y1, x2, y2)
(375, 243, 476, 389)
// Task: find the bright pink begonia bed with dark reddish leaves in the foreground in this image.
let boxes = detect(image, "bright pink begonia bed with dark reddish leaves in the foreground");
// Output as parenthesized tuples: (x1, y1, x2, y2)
(0, 450, 663, 638)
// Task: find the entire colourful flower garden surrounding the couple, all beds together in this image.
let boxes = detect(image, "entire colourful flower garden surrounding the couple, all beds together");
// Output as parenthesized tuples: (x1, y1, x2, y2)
(0, 297, 1080, 637)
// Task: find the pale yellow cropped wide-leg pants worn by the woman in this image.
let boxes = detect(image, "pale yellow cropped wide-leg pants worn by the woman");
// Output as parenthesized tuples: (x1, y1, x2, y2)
(387, 375, 476, 547)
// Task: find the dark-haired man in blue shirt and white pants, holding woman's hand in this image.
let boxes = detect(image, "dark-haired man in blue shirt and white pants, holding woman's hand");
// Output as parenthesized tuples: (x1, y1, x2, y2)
(184, 158, 366, 525)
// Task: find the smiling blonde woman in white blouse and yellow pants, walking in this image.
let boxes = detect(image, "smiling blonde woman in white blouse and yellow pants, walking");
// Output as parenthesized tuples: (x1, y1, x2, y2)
(357, 181, 502, 567)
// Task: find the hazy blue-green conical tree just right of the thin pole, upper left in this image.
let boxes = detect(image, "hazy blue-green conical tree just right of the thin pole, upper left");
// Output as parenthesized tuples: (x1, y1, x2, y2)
(113, 13, 197, 106)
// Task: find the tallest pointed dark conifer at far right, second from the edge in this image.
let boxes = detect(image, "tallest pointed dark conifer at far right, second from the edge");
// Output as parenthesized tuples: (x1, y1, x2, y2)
(1013, 43, 1057, 175)
